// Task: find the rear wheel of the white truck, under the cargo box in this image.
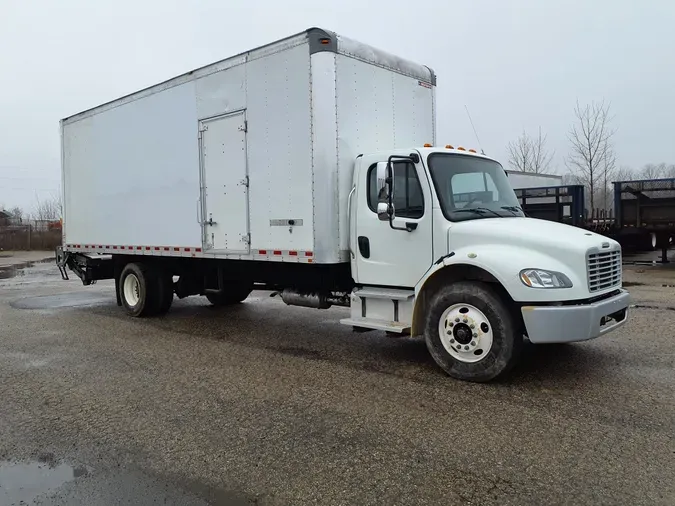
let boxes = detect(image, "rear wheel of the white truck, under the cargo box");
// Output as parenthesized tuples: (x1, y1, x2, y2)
(119, 263, 160, 317)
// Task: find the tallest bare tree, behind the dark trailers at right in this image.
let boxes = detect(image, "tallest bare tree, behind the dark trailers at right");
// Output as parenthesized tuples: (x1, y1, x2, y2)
(566, 101, 616, 209)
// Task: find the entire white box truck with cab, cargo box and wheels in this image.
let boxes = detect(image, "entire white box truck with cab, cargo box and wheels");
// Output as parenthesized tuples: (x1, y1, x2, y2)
(57, 28, 629, 381)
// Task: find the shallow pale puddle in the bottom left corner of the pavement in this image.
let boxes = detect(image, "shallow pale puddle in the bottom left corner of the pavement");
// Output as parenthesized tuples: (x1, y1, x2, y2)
(0, 457, 87, 506)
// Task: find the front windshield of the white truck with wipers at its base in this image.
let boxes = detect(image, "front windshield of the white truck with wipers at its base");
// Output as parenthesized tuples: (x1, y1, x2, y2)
(429, 153, 525, 221)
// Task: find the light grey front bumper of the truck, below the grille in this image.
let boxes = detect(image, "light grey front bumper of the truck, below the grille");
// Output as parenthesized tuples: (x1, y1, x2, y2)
(521, 290, 630, 343)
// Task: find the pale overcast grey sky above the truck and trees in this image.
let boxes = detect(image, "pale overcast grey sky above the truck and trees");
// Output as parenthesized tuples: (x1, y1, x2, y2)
(0, 0, 675, 209)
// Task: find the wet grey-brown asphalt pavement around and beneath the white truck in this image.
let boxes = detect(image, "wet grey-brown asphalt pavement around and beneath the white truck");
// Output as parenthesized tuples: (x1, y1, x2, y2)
(0, 258, 675, 506)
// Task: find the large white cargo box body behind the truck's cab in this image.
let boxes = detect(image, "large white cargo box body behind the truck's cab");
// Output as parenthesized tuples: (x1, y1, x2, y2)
(61, 29, 435, 263)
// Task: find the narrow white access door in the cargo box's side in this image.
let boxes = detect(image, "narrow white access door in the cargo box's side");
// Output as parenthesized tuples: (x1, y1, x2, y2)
(199, 111, 250, 254)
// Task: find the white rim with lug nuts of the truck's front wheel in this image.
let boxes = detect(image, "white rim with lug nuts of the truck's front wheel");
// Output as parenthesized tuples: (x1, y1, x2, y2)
(438, 304, 494, 364)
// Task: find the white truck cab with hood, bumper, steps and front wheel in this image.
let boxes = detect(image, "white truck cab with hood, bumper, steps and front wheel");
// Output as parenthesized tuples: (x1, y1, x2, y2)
(343, 146, 630, 381)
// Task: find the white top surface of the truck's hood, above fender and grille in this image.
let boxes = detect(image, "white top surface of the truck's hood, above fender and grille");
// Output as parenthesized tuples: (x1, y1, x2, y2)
(448, 217, 619, 256)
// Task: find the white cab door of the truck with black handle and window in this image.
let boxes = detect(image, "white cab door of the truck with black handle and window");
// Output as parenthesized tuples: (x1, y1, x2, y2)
(351, 157, 433, 288)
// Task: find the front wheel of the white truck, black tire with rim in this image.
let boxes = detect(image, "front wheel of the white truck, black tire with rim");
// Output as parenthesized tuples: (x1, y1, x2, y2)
(424, 281, 523, 382)
